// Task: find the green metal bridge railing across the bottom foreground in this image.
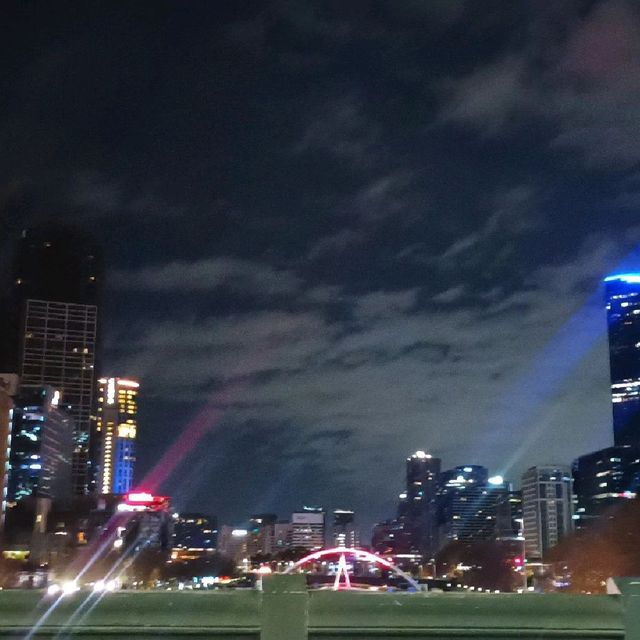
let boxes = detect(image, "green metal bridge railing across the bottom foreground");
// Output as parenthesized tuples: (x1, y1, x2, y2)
(0, 575, 640, 640)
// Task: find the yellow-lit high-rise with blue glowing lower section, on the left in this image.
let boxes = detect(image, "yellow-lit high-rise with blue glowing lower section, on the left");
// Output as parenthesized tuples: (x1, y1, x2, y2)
(95, 378, 140, 493)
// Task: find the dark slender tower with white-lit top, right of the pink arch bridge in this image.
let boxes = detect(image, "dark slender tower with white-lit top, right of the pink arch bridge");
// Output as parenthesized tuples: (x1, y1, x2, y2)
(405, 451, 441, 559)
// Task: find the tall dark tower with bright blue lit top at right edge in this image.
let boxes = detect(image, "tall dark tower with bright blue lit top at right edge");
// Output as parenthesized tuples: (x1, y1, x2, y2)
(605, 274, 640, 446)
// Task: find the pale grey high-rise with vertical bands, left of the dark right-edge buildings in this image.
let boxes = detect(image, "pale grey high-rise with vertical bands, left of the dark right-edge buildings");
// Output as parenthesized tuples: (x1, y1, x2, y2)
(522, 465, 573, 559)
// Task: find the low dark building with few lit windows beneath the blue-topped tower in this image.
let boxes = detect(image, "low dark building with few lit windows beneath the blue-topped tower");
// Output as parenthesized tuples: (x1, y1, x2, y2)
(573, 445, 640, 529)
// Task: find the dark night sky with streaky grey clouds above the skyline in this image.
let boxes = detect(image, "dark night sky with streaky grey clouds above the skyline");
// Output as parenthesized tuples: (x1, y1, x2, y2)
(0, 0, 640, 526)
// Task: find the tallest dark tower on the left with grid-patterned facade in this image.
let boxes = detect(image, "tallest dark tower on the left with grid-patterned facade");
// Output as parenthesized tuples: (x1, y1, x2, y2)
(13, 226, 102, 495)
